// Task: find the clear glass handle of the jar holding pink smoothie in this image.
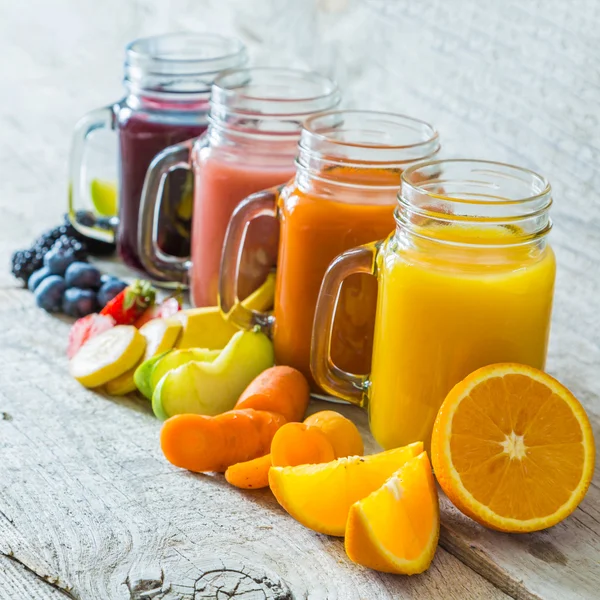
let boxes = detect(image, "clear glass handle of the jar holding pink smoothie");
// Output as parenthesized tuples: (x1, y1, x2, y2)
(138, 139, 196, 285)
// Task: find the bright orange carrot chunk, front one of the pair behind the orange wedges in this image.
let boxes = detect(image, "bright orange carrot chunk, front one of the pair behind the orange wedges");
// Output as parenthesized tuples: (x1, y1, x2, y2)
(271, 423, 336, 467)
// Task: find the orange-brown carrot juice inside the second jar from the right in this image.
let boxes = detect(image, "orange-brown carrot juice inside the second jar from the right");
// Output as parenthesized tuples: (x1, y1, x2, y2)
(273, 169, 400, 389)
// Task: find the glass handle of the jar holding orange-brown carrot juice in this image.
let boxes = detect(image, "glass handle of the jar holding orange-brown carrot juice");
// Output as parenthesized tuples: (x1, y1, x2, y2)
(219, 186, 283, 335)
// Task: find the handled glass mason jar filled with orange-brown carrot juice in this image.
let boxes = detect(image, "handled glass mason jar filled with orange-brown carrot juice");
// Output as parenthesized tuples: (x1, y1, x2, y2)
(220, 110, 440, 390)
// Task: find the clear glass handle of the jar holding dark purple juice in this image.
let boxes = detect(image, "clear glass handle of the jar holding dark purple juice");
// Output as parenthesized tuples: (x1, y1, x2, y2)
(69, 104, 118, 243)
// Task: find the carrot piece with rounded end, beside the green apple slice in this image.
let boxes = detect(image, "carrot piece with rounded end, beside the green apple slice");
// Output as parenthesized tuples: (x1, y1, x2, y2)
(235, 366, 310, 422)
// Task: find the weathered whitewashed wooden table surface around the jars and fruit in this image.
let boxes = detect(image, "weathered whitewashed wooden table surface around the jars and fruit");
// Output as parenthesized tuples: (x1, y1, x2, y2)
(0, 0, 600, 600)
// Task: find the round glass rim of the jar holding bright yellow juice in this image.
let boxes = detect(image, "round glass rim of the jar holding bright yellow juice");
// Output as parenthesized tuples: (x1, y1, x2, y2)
(398, 158, 552, 206)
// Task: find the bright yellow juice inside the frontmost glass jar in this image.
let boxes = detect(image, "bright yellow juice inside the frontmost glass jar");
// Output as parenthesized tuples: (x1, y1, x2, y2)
(368, 226, 556, 451)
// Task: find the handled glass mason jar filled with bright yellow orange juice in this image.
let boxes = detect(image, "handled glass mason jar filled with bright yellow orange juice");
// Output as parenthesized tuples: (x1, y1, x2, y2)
(311, 160, 555, 449)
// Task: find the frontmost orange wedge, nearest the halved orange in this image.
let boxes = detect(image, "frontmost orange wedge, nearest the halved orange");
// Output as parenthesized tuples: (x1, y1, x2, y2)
(345, 452, 440, 575)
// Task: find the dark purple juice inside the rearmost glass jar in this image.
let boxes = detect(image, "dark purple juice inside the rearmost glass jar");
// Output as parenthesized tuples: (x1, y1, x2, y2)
(117, 111, 207, 271)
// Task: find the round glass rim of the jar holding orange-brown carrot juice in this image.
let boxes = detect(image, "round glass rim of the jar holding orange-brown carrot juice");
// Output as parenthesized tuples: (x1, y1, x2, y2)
(303, 109, 440, 151)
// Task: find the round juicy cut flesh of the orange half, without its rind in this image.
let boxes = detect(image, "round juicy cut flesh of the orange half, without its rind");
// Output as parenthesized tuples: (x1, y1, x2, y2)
(450, 374, 584, 520)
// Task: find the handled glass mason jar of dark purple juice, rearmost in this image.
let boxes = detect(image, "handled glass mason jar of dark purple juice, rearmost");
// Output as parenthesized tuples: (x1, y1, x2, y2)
(69, 33, 246, 270)
